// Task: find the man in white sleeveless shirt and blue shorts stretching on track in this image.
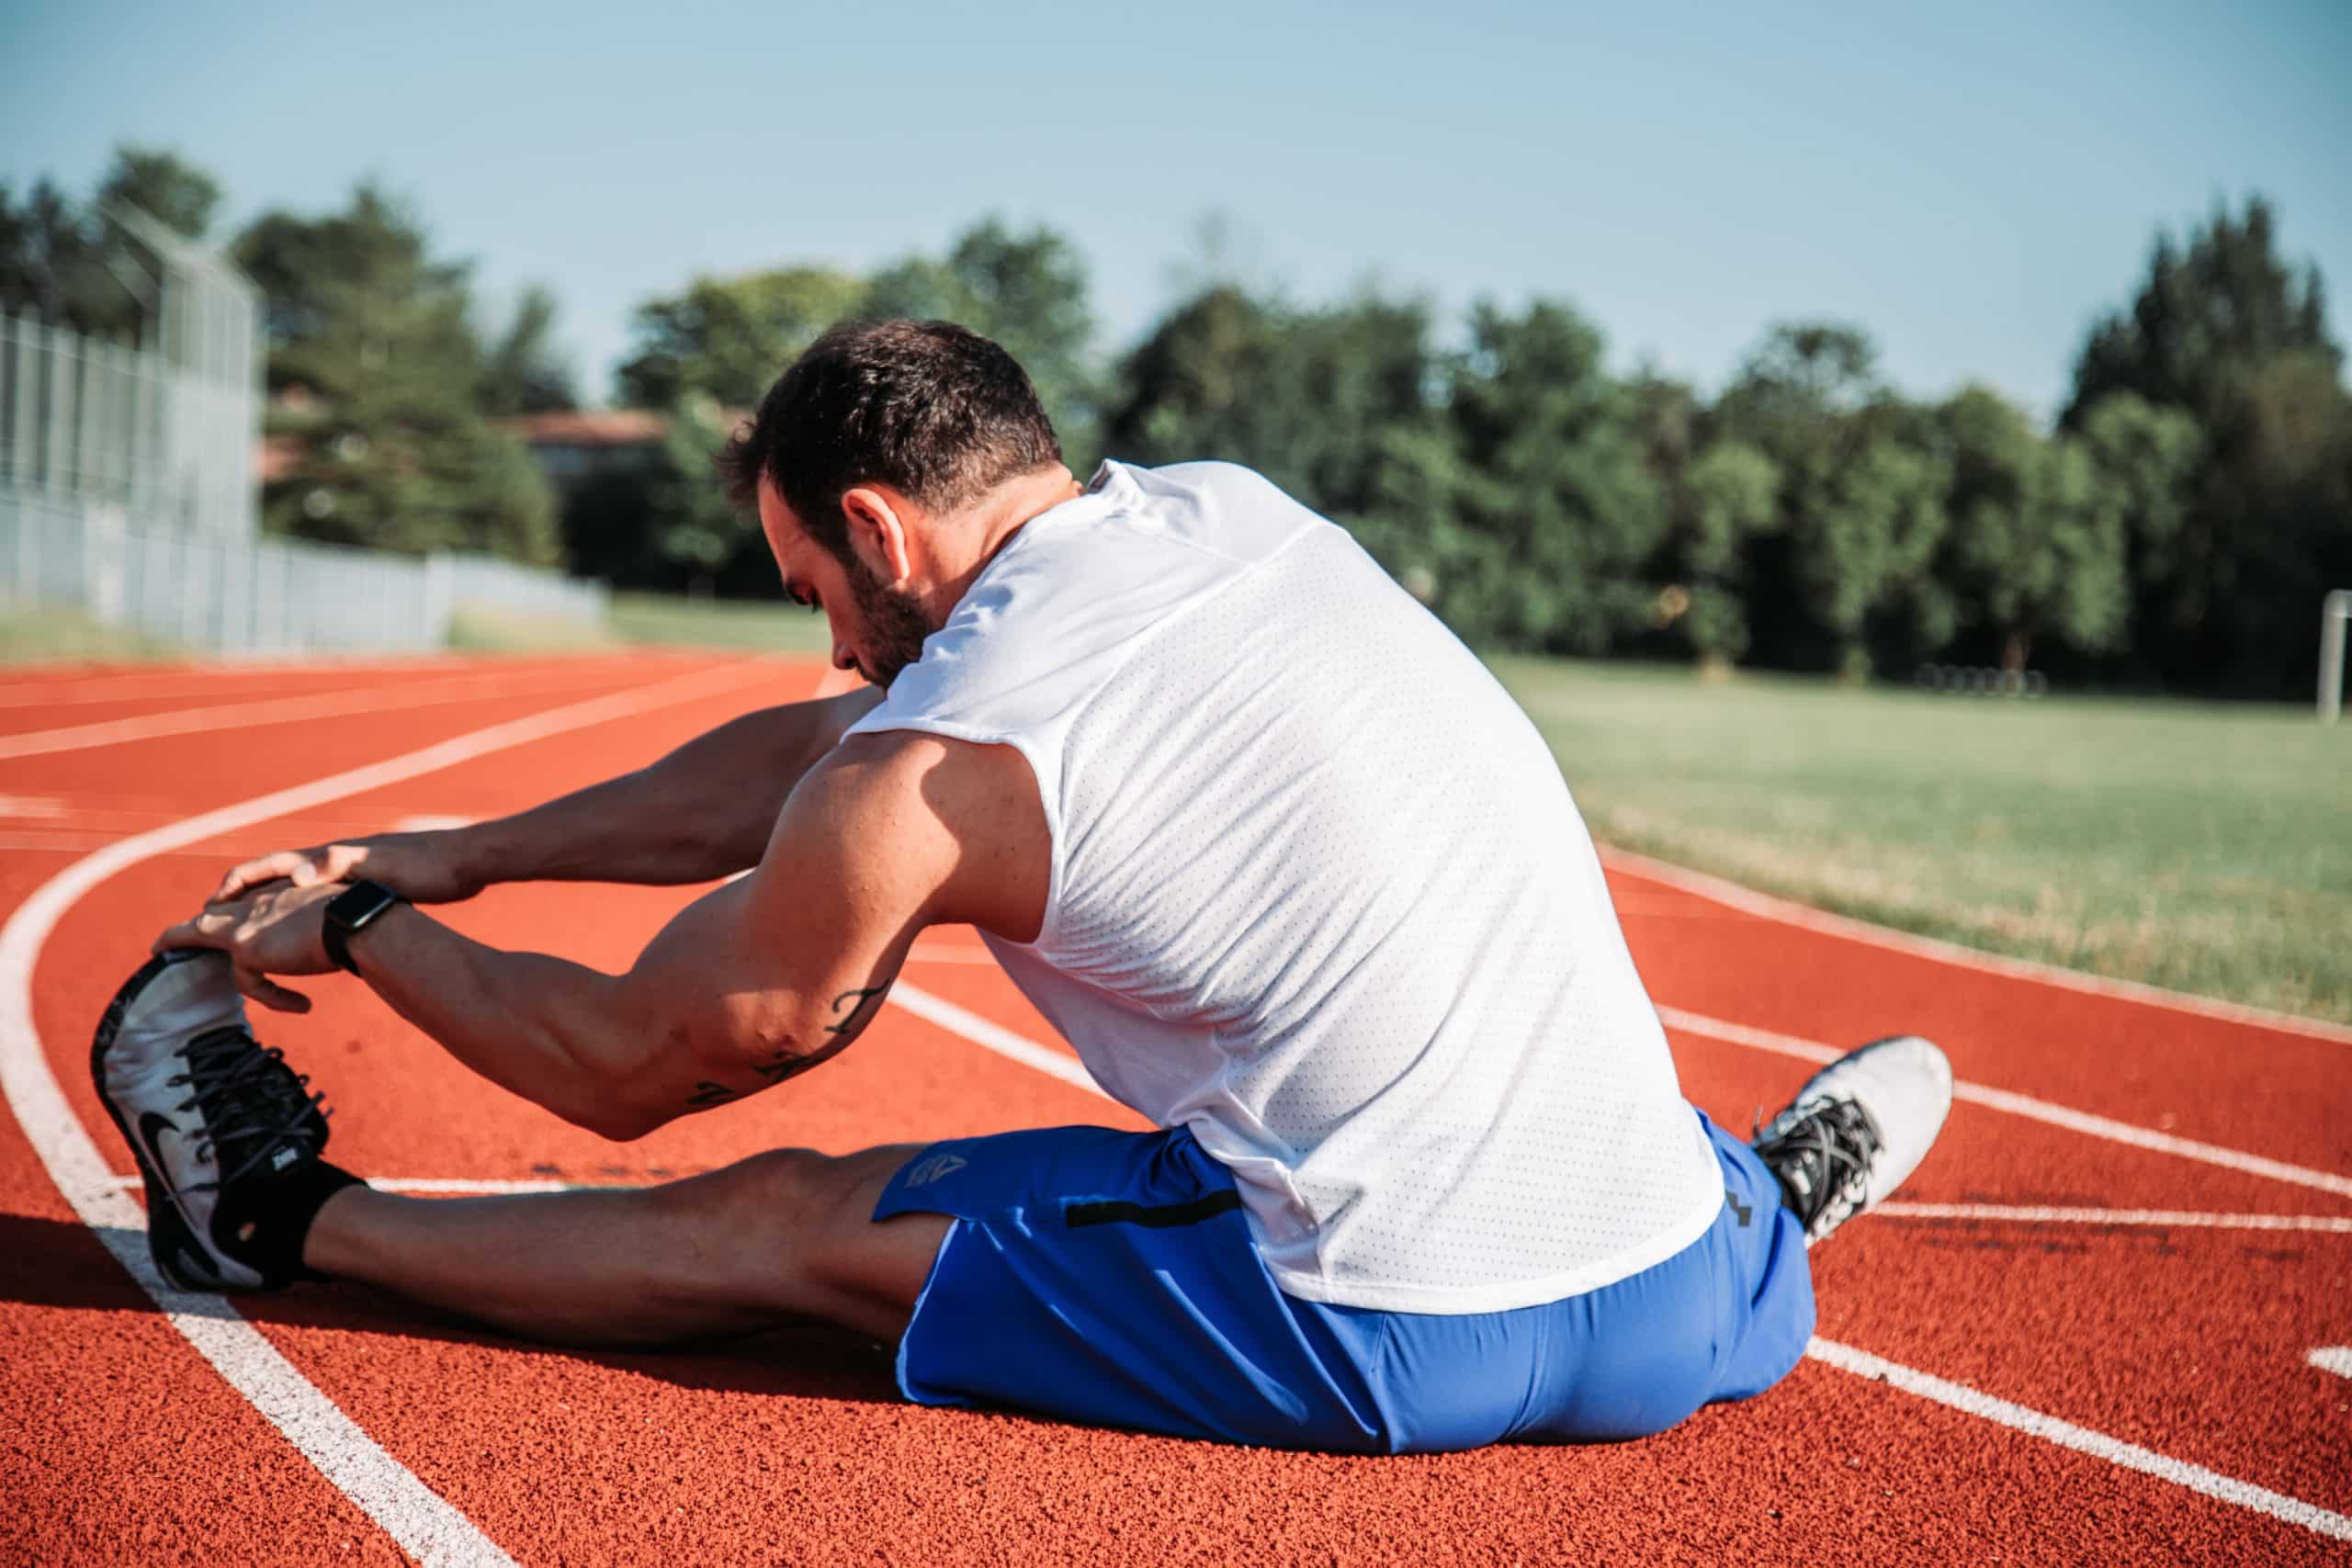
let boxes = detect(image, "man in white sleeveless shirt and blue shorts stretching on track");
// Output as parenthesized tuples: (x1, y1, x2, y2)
(94, 322, 1950, 1450)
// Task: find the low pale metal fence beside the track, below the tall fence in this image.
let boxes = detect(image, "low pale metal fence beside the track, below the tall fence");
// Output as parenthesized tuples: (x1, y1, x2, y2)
(0, 487, 606, 656)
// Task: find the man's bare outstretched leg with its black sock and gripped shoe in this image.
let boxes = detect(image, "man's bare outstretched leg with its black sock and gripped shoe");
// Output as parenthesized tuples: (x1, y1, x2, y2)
(92, 950, 948, 1345)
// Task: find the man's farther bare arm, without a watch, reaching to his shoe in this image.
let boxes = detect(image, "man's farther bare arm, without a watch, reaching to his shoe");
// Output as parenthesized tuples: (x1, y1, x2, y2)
(211, 691, 882, 903)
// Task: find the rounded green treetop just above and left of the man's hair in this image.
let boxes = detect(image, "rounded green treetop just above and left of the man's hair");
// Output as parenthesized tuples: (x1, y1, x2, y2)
(618, 265, 865, 409)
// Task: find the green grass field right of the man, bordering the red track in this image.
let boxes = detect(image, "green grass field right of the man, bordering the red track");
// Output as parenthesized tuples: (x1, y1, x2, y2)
(1496, 660, 2352, 1022)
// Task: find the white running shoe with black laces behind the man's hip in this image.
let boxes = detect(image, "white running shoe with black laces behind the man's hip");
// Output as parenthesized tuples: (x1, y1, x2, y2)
(1752, 1034, 1952, 1246)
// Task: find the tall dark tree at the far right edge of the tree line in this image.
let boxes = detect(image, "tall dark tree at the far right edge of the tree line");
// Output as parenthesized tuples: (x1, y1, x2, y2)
(2063, 197, 2352, 694)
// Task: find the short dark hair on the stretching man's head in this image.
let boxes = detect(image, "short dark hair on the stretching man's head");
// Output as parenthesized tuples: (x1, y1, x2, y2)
(719, 320, 1061, 558)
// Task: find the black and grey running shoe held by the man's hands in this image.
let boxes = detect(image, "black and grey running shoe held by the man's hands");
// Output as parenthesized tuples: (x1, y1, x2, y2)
(89, 947, 327, 1291)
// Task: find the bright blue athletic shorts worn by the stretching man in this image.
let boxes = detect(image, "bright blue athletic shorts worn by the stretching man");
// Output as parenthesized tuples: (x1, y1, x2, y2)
(875, 1110, 1814, 1453)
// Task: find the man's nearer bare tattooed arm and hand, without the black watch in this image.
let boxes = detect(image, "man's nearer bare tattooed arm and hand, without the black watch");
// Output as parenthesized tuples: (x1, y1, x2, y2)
(181, 733, 1051, 1138)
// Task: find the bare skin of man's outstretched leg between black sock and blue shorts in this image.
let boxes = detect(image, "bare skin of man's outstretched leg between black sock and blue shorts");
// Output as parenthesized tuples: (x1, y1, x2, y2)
(303, 1145, 948, 1345)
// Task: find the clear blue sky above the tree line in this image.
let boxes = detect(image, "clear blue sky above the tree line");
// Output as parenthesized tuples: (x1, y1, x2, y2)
(0, 0, 2352, 413)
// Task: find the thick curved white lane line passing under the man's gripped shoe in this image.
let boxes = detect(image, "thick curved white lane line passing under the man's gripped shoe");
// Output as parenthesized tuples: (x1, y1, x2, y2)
(0, 663, 767, 1563)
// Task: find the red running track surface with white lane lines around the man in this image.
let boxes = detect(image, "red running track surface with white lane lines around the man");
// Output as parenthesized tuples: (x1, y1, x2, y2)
(0, 656, 2352, 1563)
